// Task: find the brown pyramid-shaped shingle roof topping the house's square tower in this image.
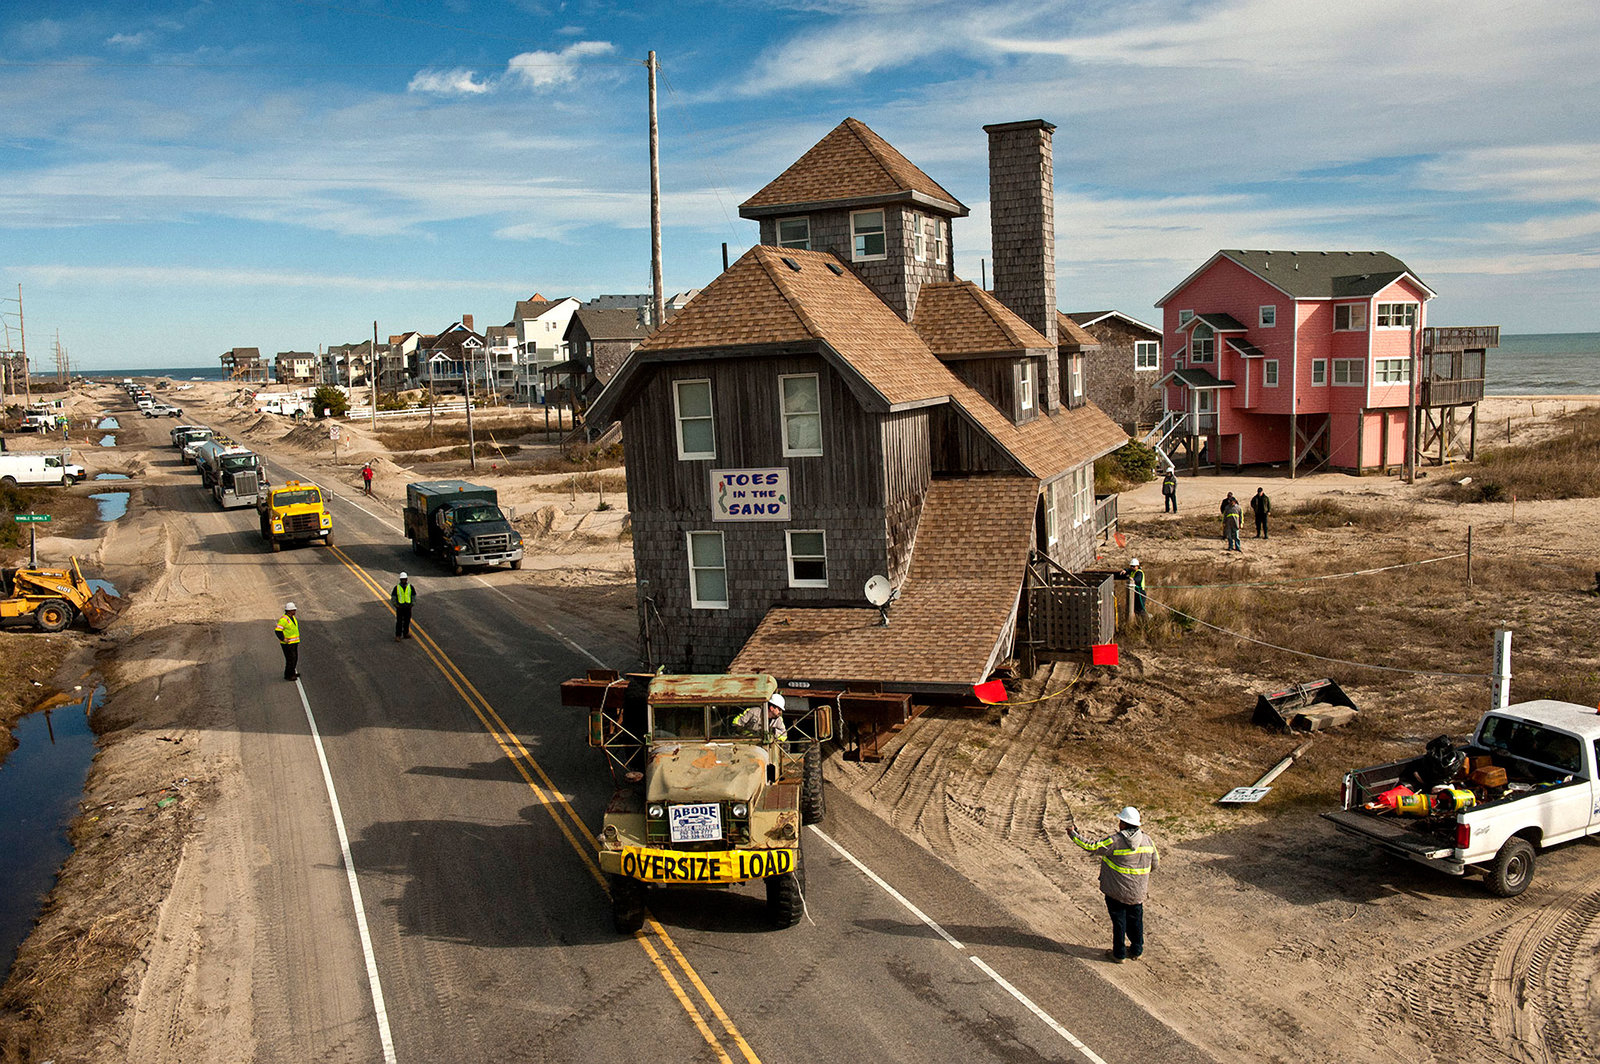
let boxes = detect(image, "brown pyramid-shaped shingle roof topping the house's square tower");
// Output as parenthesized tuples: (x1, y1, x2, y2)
(739, 118, 966, 218)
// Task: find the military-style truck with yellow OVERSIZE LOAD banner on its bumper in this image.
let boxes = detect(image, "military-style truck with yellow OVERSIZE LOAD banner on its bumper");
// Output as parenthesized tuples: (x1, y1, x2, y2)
(562, 670, 832, 934)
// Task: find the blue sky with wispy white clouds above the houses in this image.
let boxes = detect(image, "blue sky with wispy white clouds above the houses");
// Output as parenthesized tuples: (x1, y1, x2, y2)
(0, 0, 1600, 368)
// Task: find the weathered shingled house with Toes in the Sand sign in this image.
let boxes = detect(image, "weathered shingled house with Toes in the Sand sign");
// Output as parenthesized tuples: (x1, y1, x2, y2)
(592, 118, 1126, 693)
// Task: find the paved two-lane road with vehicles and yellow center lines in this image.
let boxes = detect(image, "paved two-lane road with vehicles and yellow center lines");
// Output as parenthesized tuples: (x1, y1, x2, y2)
(124, 398, 1208, 1064)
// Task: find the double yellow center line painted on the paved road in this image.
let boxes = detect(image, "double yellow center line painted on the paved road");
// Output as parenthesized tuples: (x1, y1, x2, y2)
(328, 544, 760, 1064)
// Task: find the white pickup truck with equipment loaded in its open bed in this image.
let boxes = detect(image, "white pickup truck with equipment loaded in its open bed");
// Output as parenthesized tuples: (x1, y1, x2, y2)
(1323, 699, 1600, 898)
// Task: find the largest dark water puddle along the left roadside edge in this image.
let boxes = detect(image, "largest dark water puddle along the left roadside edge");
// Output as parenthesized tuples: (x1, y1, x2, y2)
(0, 685, 106, 978)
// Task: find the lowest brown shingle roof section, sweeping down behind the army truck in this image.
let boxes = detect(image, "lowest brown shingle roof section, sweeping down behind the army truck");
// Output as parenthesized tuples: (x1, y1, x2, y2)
(730, 477, 1038, 690)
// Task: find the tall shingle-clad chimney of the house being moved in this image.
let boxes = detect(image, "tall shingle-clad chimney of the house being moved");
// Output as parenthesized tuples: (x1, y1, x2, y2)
(984, 118, 1061, 410)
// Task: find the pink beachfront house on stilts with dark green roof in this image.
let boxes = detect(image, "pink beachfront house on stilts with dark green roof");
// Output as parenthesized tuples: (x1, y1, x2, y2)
(1155, 250, 1434, 475)
